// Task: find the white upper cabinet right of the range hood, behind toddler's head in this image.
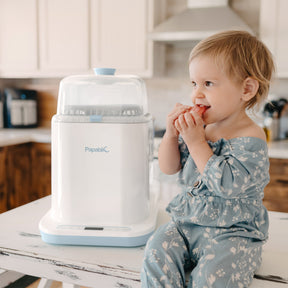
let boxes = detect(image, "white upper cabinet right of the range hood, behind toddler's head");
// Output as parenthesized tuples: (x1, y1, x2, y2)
(260, 0, 288, 78)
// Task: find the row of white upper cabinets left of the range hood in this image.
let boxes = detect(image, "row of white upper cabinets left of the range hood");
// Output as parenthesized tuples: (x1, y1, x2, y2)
(0, 0, 163, 77)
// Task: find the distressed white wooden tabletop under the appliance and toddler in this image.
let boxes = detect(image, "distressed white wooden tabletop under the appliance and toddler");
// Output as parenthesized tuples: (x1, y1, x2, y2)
(0, 196, 288, 288)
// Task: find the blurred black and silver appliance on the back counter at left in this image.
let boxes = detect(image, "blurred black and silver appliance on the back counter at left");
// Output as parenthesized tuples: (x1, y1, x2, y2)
(3, 88, 37, 128)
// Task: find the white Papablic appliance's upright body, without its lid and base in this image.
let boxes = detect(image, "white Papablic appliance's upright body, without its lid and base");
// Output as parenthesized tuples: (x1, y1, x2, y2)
(52, 117, 149, 227)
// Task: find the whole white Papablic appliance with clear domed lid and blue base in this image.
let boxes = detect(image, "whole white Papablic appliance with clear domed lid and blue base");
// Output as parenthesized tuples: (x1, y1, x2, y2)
(39, 69, 157, 246)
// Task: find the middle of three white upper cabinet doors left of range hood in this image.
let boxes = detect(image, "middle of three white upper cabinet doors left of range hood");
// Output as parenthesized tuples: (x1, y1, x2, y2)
(39, 0, 90, 75)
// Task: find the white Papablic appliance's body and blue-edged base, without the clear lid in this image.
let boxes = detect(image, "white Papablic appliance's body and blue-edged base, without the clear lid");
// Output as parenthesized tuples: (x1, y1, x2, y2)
(39, 115, 157, 246)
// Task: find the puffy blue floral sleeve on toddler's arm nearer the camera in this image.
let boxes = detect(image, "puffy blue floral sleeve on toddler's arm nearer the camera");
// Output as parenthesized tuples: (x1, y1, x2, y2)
(202, 137, 269, 199)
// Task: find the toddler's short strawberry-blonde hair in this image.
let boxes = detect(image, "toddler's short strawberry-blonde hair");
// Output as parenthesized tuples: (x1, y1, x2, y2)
(189, 30, 275, 109)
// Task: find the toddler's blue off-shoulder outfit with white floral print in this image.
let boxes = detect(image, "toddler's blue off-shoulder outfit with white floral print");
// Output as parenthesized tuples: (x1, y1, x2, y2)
(141, 137, 269, 288)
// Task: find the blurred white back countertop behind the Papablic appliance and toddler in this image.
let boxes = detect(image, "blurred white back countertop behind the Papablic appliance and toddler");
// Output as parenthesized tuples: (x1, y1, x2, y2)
(0, 128, 288, 159)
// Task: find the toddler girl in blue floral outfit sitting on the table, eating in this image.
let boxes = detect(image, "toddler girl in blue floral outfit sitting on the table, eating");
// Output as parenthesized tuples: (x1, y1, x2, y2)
(141, 31, 274, 288)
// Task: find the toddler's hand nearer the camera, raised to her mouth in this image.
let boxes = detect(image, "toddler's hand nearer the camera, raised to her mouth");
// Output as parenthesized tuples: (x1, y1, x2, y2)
(175, 106, 206, 146)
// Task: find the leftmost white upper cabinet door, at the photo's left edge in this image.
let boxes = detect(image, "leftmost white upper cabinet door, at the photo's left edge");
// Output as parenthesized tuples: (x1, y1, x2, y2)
(0, 0, 38, 77)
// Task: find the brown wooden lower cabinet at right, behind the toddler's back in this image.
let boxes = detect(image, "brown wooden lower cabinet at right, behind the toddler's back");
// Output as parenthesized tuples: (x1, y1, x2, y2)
(264, 158, 288, 212)
